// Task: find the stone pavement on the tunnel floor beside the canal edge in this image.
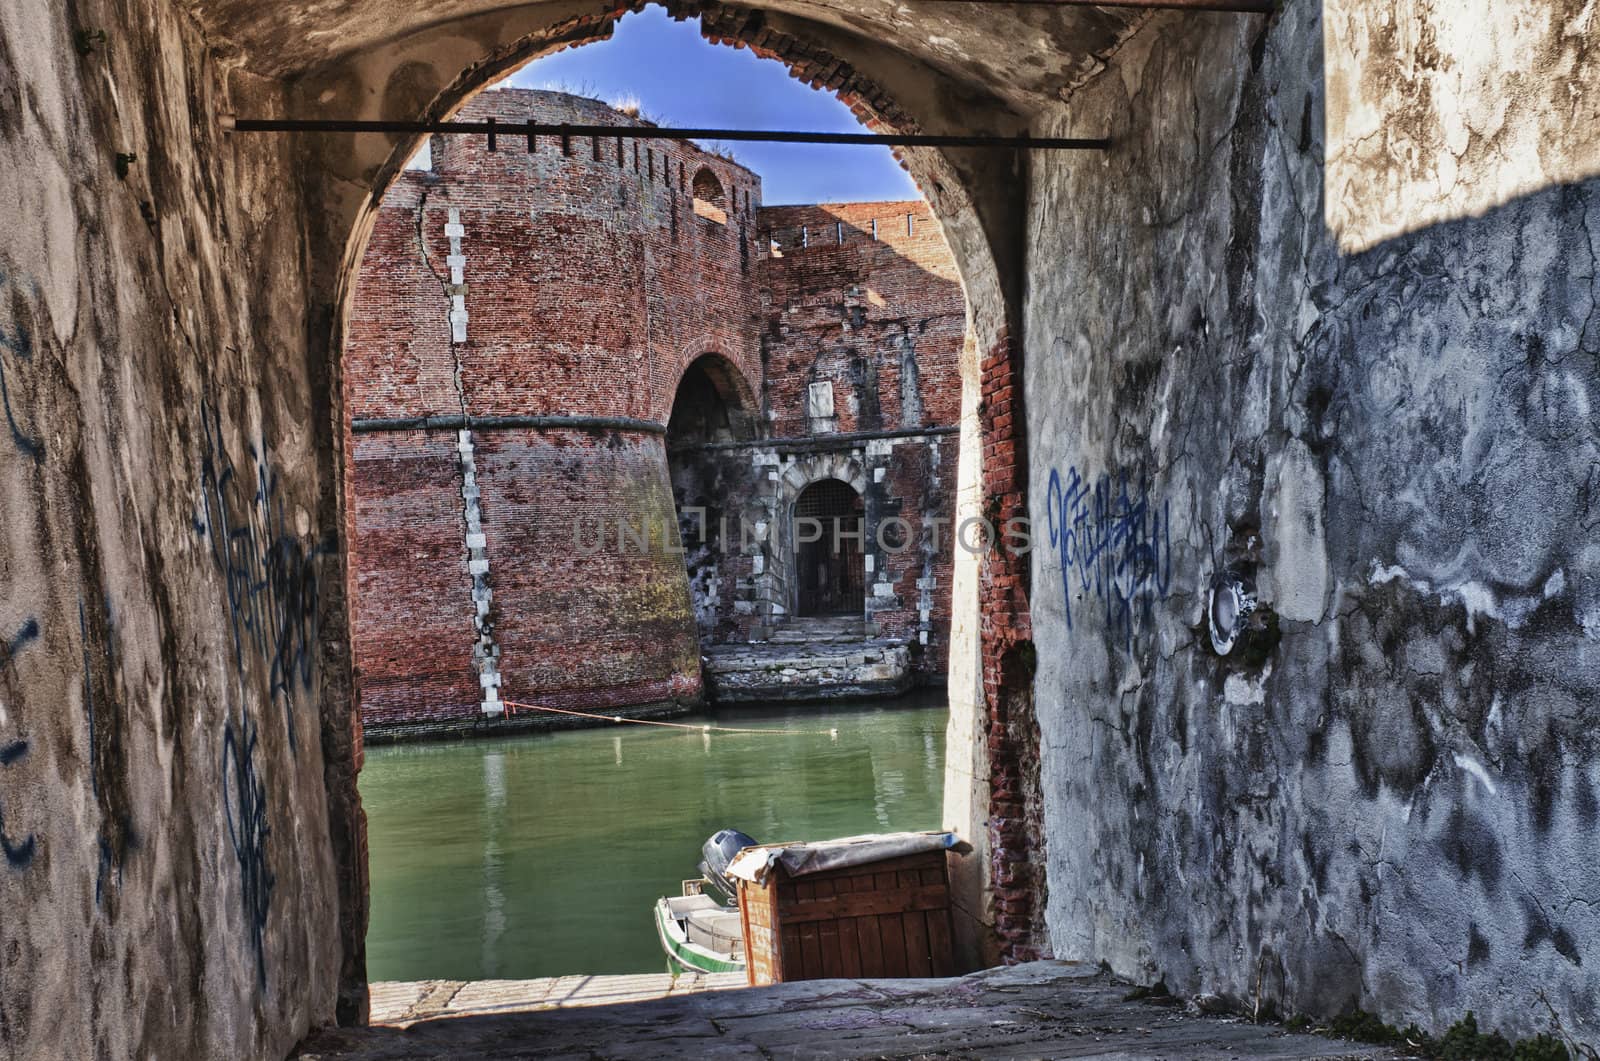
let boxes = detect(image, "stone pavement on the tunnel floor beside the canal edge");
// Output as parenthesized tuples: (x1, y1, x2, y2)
(294, 962, 1395, 1061)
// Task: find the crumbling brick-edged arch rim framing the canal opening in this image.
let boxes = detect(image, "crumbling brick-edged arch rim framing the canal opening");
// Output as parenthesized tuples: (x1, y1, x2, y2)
(321, 0, 1029, 1021)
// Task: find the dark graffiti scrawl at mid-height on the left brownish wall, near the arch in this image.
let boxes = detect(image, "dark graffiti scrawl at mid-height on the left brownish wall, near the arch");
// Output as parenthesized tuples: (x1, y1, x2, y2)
(195, 405, 326, 751)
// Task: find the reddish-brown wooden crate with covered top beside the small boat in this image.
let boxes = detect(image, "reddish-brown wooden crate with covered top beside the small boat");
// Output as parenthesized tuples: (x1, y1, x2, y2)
(739, 851, 955, 986)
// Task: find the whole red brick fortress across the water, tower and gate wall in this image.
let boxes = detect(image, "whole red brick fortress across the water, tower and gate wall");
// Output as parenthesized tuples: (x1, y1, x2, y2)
(346, 90, 965, 730)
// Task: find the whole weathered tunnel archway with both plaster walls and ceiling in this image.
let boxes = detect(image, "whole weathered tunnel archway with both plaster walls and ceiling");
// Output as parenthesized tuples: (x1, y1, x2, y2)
(12, 0, 1600, 1056)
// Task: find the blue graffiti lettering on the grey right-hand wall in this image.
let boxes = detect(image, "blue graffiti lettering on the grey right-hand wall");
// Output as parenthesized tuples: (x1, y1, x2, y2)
(1045, 467, 1173, 650)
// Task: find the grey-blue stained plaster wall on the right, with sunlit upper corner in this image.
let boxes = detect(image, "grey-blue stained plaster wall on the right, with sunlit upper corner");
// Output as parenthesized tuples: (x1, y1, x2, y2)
(1026, 0, 1600, 1043)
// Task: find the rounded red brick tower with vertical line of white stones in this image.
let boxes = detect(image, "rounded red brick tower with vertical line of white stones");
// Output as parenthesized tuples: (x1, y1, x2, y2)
(346, 91, 760, 723)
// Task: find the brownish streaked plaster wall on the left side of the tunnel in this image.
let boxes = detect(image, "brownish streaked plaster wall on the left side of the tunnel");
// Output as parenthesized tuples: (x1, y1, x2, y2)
(0, 0, 347, 1058)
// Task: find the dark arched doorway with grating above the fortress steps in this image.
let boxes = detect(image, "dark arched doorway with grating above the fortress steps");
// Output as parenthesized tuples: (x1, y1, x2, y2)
(795, 478, 866, 616)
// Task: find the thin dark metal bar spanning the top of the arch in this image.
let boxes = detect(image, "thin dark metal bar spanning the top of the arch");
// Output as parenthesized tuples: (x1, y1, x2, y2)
(222, 115, 1110, 150)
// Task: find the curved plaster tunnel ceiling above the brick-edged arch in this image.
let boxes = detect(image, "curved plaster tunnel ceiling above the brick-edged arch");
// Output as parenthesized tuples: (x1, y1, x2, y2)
(194, 0, 1149, 110)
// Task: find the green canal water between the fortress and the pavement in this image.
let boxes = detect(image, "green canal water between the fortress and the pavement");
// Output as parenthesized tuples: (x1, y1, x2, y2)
(360, 698, 947, 981)
